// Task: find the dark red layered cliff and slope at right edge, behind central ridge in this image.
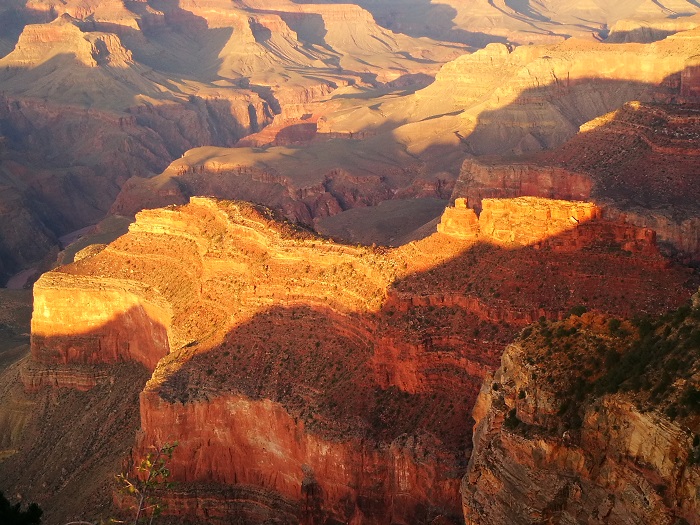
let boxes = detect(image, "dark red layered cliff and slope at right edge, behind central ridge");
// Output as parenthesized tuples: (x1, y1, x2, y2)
(453, 103, 700, 260)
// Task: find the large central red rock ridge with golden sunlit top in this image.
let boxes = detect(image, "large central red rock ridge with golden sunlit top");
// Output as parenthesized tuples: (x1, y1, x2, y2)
(22, 197, 693, 523)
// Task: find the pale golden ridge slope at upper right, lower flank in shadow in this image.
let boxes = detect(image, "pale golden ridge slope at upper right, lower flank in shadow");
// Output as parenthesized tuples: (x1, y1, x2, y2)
(386, 30, 700, 155)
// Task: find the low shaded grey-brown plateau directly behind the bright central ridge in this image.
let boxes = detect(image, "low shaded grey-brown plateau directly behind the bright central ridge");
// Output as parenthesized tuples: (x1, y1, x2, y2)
(106, 143, 452, 226)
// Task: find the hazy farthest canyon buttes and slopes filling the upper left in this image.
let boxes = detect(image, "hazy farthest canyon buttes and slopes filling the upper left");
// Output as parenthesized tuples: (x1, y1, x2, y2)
(0, 1, 464, 280)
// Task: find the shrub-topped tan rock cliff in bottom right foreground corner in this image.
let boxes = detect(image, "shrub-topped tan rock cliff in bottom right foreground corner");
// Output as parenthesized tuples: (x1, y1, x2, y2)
(462, 298, 700, 525)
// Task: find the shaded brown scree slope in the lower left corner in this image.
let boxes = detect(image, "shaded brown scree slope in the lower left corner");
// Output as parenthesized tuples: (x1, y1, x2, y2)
(0, 363, 149, 523)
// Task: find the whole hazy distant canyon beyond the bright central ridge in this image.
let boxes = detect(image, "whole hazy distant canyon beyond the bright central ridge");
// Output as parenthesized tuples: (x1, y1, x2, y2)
(0, 0, 698, 286)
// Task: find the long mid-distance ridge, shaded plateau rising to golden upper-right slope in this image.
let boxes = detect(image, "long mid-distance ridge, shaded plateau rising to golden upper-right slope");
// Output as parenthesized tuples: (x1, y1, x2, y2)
(112, 27, 700, 237)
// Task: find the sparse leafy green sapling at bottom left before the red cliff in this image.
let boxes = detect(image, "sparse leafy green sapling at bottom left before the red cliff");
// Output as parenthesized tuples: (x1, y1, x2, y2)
(117, 441, 178, 525)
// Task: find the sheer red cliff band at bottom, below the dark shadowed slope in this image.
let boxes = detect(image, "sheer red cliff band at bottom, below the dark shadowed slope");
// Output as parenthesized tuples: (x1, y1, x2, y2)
(136, 390, 457, 523)
